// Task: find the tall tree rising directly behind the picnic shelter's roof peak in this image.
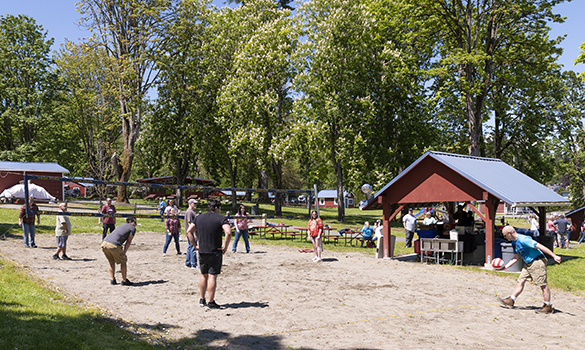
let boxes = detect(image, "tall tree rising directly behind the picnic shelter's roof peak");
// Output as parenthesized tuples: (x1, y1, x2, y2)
(417, 0, 562, 156)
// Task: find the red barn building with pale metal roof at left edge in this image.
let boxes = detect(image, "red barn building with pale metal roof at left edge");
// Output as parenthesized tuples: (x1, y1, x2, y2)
(0, 161, 69, 201)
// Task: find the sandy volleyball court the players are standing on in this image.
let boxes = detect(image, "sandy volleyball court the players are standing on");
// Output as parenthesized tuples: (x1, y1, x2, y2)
(0, 231, 585, 349)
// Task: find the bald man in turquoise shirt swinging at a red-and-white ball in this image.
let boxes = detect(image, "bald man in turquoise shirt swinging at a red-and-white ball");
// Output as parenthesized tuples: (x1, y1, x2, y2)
(498, 226, 561, 314)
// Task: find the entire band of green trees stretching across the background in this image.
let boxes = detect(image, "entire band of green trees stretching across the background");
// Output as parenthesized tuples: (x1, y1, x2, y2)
(0, 0, 585, 215)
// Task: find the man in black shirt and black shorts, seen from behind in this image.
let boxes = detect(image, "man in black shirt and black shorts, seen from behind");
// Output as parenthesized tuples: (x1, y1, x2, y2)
(187, 199, 232, 309)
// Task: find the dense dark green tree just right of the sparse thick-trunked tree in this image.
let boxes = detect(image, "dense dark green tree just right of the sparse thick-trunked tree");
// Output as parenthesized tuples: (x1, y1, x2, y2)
(142, 1, 214, 204)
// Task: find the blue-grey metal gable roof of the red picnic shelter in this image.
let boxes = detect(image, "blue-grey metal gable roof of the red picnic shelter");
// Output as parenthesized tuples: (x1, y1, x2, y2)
(365, 151, 570, 208)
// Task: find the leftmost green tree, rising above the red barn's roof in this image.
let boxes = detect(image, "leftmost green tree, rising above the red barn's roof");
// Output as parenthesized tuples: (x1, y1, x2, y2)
(0, 15, 59, 161)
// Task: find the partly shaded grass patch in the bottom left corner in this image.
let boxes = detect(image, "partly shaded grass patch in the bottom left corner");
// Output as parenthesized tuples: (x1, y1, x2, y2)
(0, 259, 172, 349)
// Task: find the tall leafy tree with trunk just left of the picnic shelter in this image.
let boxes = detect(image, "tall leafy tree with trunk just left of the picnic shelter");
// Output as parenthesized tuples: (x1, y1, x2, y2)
(296, 0, 377, 222)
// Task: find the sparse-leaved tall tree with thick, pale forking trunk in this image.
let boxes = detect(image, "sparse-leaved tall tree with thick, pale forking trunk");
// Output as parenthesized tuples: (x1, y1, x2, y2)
(78, 0, 174, 202)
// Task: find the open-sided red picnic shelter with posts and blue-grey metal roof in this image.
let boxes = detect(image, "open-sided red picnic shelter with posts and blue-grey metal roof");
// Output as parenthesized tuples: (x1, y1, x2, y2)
(363, 151, 570, 264)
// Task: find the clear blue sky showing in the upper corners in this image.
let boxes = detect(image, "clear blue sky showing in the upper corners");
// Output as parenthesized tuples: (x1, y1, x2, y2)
(0, 0, 585, 73)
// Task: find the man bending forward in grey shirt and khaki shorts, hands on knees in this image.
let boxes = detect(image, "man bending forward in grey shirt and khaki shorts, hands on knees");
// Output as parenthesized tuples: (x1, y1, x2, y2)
(101, 216, 136, 286)
